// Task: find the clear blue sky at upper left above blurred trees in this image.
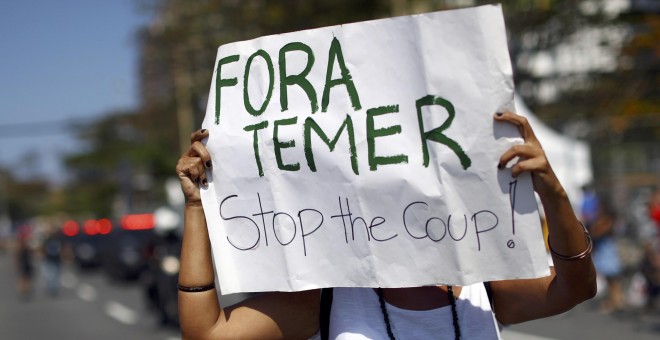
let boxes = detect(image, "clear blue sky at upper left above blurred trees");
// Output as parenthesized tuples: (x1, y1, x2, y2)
(0, 0, 147, 182)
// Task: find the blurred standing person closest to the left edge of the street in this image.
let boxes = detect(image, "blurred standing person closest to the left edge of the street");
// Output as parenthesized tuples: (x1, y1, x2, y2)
(15, 224, 34, 300)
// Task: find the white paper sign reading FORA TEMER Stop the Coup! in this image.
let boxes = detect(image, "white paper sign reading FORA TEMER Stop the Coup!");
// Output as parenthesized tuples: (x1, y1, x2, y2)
(202, 6, 549, 294)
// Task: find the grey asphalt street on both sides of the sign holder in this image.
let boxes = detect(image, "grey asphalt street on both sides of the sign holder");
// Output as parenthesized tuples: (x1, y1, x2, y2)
(0, 253, 660, 340)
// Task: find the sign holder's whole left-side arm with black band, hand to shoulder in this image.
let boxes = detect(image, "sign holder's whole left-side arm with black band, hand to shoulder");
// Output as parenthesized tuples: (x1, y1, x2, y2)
(176, 130, 320, 339)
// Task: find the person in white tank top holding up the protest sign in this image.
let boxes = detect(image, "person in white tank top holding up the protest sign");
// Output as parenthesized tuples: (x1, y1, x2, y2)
(176, 112, 596, 339)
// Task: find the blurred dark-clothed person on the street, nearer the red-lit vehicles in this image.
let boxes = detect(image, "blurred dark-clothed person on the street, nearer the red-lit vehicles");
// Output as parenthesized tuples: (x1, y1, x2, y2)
(42, 225, 64, 296)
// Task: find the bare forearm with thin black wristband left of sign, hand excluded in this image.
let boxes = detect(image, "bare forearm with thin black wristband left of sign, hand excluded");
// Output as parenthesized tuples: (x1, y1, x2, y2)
(179, 203, 222, 338)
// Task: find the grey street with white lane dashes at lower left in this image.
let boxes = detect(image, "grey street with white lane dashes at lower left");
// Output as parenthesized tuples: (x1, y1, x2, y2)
(0, 252, 249, 340)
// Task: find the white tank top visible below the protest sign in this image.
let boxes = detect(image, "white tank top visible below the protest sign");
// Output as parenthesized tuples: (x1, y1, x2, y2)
(329, 283, 500, 340)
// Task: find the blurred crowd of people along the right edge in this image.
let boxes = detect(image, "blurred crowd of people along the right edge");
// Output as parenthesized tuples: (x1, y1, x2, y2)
(580, 187, 660, 313)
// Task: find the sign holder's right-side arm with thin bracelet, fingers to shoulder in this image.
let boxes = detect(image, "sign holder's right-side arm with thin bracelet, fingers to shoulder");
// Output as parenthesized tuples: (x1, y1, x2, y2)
(492, 112, 596, 324)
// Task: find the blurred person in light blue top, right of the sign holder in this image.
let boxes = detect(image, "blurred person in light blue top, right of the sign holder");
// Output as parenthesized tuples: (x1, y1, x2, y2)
(589, 201, 624, 313)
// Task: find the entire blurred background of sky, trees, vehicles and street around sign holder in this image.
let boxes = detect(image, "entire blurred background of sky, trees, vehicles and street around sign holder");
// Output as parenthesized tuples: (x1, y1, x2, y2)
(0, 0, 660, 339)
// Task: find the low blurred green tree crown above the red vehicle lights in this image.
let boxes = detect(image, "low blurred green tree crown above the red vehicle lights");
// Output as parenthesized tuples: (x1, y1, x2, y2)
(61, 112, 170, 217)
